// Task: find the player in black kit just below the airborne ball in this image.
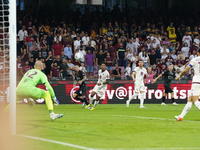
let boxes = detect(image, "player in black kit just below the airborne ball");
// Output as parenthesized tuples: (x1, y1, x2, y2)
(73, 65, 89, 107)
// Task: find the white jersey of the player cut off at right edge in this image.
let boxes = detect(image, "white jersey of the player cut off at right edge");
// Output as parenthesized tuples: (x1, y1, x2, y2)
(189, 56, 200, 83)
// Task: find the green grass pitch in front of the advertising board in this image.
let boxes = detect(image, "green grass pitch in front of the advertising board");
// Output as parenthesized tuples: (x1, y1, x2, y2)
(17, 104, 200, 150)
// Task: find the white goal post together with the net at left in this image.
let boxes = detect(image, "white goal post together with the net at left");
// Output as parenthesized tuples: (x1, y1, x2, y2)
(0, 0, 17, 134)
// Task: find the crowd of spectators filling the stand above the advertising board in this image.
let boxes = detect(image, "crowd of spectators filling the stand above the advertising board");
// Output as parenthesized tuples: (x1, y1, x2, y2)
(7, 5, 200, 83)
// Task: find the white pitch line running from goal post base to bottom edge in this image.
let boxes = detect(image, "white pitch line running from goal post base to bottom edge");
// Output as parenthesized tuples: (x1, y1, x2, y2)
(18, 134, 97, 150)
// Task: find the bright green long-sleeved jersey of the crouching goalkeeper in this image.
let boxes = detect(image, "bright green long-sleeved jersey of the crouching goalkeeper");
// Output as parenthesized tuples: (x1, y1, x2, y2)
(17, 69, 55, 98)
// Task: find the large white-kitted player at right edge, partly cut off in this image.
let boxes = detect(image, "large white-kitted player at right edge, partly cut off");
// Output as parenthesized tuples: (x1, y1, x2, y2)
(175, 48, 200, 121)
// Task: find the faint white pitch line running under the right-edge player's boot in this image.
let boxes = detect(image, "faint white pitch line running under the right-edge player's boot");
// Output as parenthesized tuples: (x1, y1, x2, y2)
(111, 115, 200, 123)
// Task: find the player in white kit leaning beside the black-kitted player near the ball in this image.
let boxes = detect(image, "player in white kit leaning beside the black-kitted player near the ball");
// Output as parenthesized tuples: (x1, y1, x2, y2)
(85, 62, 110, 110)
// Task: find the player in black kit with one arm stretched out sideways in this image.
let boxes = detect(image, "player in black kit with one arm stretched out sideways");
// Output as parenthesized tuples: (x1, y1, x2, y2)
(153, 64, 178, 106)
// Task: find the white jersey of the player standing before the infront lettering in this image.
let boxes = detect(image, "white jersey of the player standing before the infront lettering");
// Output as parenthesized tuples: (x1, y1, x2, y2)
(134, 67, 147, 84)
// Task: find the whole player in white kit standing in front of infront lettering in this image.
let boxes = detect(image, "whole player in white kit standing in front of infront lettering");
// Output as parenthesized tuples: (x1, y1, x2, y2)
(126, 60, 149, 108)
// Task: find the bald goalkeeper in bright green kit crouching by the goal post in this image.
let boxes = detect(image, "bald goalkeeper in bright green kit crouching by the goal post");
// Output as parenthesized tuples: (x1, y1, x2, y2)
(16, 61, 63, 121)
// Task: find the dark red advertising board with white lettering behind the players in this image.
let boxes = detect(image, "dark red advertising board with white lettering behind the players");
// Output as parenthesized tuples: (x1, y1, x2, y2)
(0, 80, 194, 104)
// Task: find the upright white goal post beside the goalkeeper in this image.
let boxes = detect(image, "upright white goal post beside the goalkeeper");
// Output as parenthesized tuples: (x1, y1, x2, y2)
(8, 0, 17, 135)
